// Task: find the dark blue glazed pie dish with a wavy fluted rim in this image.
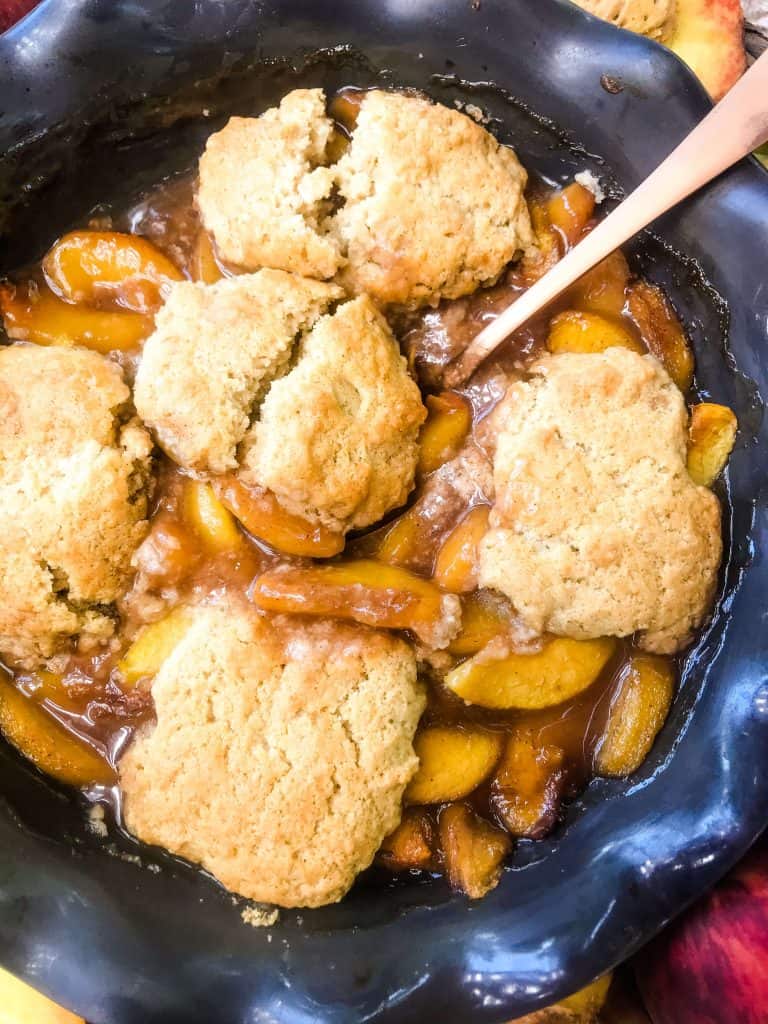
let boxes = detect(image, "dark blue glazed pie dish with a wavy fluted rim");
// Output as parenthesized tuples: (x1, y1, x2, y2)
(0, 0, 768, 1024)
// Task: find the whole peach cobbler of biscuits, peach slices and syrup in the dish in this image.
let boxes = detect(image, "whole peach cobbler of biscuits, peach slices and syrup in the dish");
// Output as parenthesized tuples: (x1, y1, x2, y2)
(0, 88, 736, 906)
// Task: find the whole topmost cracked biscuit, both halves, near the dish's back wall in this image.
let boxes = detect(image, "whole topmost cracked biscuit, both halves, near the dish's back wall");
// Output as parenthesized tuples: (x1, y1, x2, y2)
(198, 89, 532, 308)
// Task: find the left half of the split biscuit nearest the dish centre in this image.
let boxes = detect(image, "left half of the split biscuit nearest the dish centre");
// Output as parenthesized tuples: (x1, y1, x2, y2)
(135, 270, 342, 473)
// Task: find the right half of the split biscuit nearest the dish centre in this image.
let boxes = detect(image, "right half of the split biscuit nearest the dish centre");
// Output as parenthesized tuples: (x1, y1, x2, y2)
(241, 297, 426, 530)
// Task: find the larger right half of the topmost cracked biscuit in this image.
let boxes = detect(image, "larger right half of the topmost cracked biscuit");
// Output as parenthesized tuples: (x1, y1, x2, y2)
(330, 90, 532, 307)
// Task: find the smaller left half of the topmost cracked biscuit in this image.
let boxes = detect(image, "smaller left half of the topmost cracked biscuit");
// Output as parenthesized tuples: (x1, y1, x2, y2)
(198, 89, 341, 280)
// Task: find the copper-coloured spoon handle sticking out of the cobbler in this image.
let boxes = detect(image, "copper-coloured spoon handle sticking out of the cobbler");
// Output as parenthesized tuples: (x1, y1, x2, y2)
(445, 51, 768, 387)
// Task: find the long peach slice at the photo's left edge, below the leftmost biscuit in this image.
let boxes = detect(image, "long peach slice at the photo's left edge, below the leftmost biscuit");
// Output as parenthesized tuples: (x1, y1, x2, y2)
(0, 679, 116, 786)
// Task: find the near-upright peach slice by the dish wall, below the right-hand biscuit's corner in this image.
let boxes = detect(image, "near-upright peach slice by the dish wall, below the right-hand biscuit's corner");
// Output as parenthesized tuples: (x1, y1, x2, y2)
(595, 653, 675, 775)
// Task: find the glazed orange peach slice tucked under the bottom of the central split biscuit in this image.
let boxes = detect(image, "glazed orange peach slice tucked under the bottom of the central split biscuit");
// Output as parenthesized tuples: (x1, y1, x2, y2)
(214, 476, 344, 558)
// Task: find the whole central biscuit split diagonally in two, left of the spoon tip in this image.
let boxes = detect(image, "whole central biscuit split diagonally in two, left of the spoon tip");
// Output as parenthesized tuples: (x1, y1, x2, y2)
(135, 270, 426, 531)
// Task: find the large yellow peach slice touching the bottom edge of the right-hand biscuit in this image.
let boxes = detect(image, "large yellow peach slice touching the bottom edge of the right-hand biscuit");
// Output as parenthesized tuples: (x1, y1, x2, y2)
(445, 637, 615, 711)
